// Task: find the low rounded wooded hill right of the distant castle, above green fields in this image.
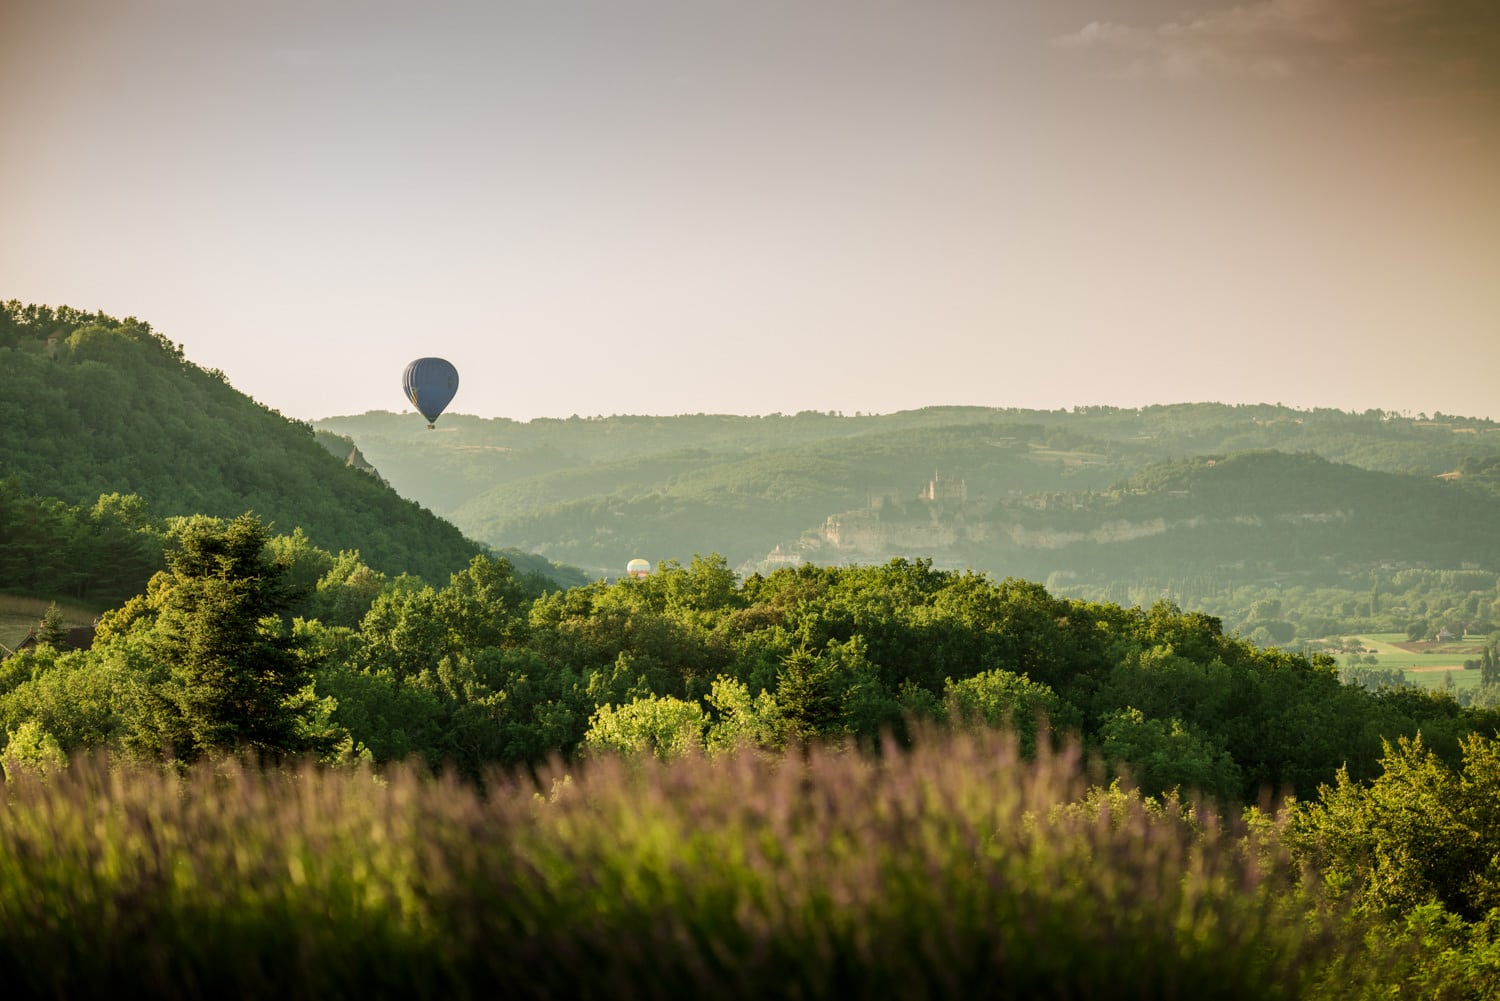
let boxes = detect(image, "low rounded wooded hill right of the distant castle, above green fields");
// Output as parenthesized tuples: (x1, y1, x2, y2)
(989, 450, 1500, 584)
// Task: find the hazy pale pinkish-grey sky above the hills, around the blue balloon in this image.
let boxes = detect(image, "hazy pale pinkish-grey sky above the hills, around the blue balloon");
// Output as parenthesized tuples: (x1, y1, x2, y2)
(0, 0, 1500, 419)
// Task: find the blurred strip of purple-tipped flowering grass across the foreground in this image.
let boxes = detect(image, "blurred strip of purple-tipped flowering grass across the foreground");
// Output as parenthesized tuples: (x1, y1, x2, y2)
(0, 734, 1382, 998)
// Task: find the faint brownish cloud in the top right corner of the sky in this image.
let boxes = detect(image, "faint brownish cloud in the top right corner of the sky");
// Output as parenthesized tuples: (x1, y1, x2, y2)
(1058, 0, 1500, 96)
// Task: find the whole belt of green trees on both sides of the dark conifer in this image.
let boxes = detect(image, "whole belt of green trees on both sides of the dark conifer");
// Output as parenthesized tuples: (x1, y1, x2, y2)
(11, 540, 1500, 803)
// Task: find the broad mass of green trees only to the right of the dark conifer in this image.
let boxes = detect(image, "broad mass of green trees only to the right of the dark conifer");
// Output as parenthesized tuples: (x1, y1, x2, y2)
(310, 560, 1500, 801)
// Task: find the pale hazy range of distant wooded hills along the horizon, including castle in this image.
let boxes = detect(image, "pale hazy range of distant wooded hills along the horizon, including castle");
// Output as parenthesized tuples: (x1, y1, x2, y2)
(320, 404, 1500, 584)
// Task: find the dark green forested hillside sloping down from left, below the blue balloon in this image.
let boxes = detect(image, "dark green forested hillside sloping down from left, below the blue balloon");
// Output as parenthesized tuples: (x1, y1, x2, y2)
(0, 302, 480, 582)
